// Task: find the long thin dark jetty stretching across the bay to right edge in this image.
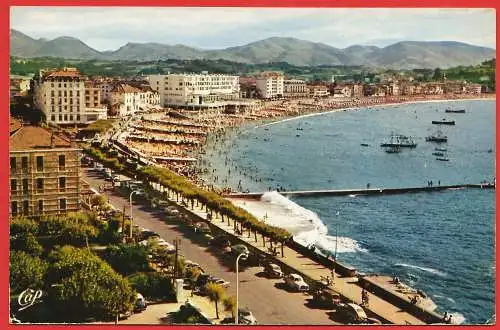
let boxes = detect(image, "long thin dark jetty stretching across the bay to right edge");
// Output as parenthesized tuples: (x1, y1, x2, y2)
(224, 183, 495, 199)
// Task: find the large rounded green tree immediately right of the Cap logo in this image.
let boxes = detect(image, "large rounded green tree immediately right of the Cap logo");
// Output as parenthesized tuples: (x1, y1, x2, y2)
(46, 246, 135, 322)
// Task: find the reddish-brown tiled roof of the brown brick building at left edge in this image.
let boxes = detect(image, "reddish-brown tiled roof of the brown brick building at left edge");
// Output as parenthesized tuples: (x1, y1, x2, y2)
(9, 126, 71, 151)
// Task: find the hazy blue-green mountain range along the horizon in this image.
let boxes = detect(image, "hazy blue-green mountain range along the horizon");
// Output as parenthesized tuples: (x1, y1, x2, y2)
(10, 29, 496, 69)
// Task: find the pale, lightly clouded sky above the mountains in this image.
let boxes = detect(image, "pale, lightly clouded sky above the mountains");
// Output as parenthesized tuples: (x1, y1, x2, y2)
(10, 7, 496, 51)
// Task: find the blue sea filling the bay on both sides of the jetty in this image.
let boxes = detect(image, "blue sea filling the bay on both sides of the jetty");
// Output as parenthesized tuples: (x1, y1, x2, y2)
(199, 100, 496, 324)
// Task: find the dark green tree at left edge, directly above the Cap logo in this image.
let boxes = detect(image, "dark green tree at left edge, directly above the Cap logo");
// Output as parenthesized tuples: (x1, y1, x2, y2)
(9, 251, 48, 293)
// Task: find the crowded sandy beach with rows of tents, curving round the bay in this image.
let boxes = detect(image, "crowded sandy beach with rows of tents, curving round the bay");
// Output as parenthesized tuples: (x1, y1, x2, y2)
(120, 95, 492, 191)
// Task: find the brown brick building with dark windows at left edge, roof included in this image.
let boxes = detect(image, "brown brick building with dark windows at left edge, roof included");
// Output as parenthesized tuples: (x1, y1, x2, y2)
(9, 125, 81, 217)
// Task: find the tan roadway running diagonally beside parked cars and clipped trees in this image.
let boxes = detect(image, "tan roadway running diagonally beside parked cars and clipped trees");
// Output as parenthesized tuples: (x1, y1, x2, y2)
(82, 168, 339, 325)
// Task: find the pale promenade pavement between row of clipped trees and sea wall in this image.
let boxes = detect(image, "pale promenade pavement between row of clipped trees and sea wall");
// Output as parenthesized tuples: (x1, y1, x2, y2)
(155, 186, 426, 325)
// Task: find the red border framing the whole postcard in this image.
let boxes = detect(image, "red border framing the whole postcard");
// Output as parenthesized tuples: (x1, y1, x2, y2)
(0, 0, 499, 329)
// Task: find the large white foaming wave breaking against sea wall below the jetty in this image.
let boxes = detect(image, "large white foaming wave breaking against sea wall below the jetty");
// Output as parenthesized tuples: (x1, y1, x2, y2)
(261, 191, 367, 253)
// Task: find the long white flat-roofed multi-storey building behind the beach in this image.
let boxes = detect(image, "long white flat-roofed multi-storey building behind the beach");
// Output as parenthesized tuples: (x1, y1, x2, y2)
(148, 73, 240, 107)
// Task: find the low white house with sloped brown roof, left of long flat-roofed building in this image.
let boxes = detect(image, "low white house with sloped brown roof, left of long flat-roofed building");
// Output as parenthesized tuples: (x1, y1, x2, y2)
(110, 84, 160, 116)
